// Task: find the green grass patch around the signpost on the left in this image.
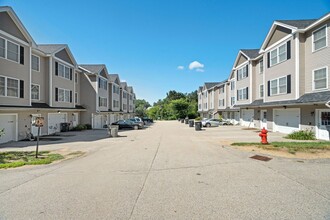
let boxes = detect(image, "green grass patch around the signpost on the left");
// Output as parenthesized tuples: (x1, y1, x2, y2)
(0, 151, 64, 169)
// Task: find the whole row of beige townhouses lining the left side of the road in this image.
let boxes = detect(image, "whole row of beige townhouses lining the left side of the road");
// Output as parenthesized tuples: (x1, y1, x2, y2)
(0, 7, 135, 143)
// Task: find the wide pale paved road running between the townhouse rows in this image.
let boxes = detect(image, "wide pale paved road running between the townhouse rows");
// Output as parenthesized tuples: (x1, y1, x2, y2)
(0, 122, 330, 220)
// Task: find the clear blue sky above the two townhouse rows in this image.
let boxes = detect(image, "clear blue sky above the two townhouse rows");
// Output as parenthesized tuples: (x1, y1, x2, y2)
(0, 0, 330, 104)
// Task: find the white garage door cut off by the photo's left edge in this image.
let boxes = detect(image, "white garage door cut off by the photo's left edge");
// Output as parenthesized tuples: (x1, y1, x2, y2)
(0, 115, 17, 143)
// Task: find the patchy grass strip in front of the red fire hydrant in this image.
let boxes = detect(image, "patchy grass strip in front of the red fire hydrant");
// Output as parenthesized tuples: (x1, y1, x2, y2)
(231, 141, 330, 154)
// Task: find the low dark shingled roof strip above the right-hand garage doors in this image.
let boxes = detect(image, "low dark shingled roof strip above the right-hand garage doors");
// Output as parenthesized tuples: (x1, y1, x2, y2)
(237, 91, 330, 107)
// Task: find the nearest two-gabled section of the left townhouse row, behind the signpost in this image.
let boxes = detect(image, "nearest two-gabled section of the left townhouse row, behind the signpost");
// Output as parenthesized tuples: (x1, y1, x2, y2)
(0, 7, 84, 143)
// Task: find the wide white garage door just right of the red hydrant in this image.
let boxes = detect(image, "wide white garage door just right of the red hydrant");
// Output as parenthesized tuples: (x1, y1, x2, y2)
(274, 109, 300, 134)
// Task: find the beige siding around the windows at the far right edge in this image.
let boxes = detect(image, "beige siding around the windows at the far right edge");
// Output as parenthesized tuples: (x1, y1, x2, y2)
(305, 20, 330, 93)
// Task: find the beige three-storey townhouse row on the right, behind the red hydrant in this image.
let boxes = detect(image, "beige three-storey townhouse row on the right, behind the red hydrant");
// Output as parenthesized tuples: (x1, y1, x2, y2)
(198, 13, 330, 140)
